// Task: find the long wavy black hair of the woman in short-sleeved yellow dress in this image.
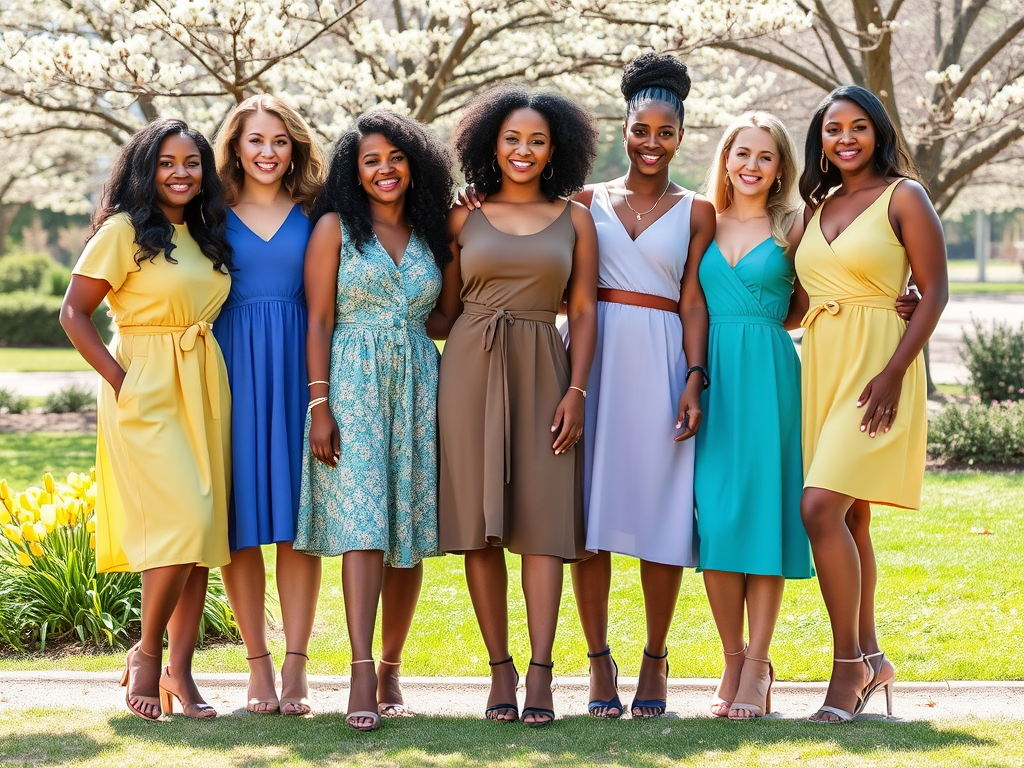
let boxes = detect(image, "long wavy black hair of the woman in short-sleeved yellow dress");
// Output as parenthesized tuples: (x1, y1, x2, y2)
(89, 118, 232, 271)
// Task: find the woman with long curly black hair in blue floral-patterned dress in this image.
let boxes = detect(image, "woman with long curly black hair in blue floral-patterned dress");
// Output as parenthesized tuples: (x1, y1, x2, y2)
(295, 111, 452, 731)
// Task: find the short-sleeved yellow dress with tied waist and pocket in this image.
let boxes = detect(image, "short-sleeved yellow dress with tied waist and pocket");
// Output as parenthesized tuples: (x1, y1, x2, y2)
(74, 214, 231, 571)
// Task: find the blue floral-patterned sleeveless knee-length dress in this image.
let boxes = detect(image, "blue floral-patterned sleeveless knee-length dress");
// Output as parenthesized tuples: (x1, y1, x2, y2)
(294, 219, 441, 568)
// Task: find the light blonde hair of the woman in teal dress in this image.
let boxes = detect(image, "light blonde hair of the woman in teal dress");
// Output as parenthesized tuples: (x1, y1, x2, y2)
(705, 112, 799, 248)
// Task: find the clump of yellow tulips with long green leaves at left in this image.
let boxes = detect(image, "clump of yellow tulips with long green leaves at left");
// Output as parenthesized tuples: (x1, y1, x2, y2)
(0, 473, 239, 651)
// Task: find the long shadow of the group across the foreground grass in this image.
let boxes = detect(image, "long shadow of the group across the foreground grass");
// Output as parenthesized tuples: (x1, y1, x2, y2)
(94, 714, 998, 768)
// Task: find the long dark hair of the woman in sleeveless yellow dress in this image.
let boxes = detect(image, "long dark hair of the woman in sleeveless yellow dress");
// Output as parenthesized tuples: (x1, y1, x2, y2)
(800, 85, 921, 208)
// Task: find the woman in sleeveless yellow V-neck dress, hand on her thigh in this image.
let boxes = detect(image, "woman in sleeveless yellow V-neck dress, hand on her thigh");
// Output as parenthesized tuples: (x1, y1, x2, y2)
(796, 86, 948, 723)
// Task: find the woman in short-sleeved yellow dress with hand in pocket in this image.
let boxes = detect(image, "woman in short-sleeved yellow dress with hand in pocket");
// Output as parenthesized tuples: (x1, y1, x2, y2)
(60, 119, 231, 720)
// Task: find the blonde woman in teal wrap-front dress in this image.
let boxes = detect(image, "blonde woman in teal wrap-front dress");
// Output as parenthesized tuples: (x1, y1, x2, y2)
(694, 113, 814, 720)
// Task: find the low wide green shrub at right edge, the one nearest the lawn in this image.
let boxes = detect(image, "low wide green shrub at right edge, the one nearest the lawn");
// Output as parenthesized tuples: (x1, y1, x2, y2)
(928, 400, 1024, 466)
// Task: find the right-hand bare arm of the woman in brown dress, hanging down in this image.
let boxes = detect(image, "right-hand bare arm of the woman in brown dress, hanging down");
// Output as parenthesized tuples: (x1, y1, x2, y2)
(551, 202, 597, 454)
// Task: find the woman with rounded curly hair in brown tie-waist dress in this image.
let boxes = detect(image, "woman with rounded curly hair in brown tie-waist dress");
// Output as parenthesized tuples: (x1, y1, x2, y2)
(430, 86, 597, 726)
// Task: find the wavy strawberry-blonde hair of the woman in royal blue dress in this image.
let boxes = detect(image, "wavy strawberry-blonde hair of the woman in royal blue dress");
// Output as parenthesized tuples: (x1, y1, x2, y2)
(214, 93, 325, 214)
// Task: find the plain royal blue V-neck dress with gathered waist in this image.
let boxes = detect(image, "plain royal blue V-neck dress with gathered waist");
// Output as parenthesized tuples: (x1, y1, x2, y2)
(213, 205, 311, 552)
